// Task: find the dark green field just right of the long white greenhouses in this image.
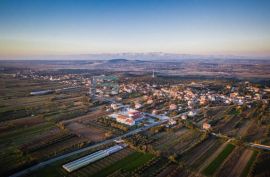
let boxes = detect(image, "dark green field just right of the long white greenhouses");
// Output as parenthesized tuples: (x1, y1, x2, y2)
(94, 152, 154, 177)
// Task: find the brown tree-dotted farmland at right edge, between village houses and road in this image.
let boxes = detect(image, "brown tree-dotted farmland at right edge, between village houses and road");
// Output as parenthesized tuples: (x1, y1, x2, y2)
(210, 102, 270, 145)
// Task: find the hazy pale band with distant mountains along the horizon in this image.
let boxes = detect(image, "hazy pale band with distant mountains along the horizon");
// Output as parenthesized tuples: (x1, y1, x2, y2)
(0, 52, 270, 60)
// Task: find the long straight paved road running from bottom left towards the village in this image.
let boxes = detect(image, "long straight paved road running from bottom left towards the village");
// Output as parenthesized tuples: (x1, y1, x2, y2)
(10, 120, 168, 177)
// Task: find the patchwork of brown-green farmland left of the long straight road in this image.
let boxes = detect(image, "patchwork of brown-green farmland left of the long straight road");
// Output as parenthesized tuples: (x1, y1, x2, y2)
(0, 75, 116, 176)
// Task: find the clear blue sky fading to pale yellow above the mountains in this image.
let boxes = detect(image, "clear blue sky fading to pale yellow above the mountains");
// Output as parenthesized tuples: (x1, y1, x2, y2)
(0, 0, 270, 59)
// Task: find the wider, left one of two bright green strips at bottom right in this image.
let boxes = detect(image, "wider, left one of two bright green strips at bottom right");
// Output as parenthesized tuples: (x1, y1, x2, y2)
(203, 144, 235, 176)
